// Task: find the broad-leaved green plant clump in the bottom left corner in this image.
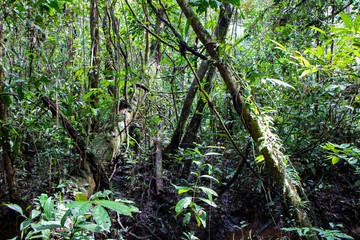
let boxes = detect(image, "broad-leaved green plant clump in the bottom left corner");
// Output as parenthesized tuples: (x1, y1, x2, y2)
(5, 190, 139, 239)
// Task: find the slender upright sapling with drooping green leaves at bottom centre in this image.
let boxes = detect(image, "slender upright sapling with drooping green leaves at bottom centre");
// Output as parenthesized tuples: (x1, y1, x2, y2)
(173, 149, 218, 227)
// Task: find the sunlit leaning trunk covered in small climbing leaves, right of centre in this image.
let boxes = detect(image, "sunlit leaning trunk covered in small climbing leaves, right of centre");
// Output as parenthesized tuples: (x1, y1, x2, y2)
(176, 0, 311, 227)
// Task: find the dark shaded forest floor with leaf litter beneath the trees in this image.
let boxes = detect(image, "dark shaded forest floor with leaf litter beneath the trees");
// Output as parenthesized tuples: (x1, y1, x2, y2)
(0, 158, 360, 240)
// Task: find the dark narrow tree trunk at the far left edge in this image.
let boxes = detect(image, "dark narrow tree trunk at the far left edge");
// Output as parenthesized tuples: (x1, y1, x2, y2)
(0, 22, 16, 193)
